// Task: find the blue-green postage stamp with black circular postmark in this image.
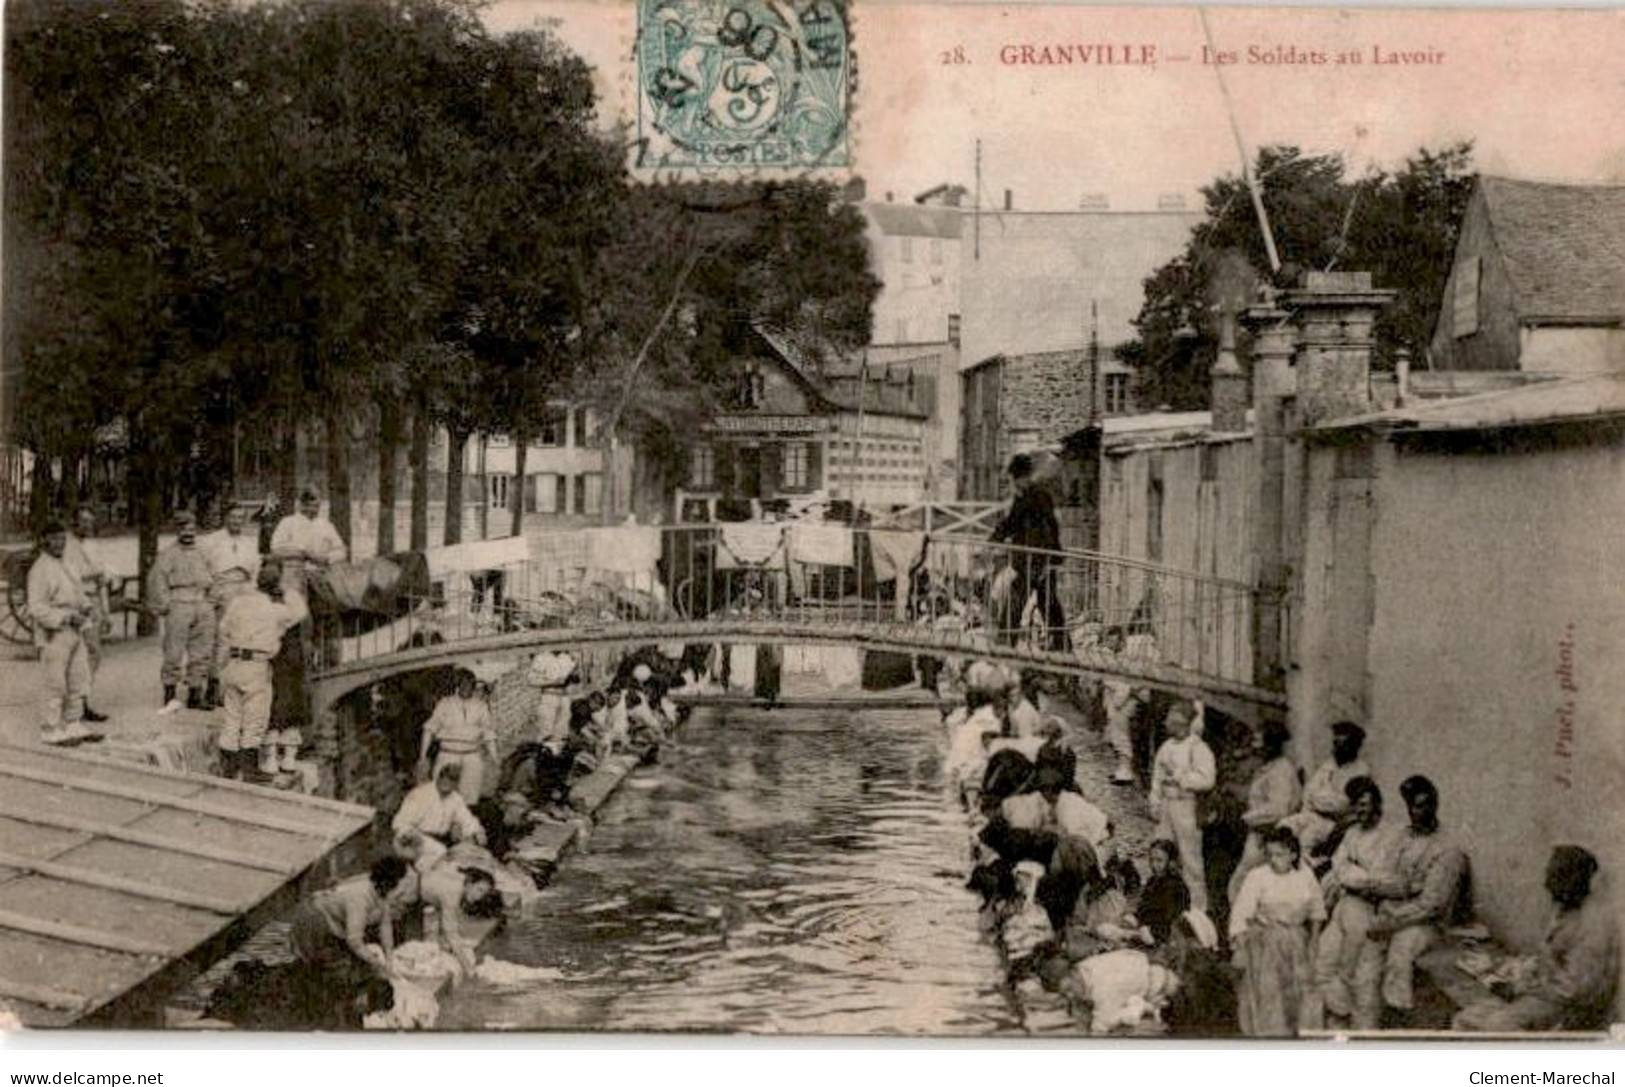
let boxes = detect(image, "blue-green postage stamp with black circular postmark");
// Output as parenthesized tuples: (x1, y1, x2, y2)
(635, 0, 853, 171)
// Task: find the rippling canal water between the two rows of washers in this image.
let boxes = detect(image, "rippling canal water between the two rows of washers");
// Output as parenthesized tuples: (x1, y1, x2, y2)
(439, 708, 1079, 1035)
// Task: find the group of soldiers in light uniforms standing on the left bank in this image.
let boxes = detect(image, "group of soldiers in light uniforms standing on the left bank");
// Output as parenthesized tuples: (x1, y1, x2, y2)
(28, 491, 348, 780)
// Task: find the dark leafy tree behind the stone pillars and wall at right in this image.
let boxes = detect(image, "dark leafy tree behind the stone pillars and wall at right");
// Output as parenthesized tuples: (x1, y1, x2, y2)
(1118, 143, 1474, 402)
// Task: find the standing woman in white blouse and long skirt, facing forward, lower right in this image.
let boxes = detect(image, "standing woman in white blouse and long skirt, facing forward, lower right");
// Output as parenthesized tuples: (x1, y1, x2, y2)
(1230, 827, 1326, 1037)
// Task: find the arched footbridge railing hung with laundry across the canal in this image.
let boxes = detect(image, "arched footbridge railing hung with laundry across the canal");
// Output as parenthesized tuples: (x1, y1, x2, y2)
(313, 523, 1253, 684)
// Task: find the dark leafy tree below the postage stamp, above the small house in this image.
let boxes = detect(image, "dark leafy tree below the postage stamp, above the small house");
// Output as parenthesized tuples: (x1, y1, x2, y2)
(580, 180, 879, 503)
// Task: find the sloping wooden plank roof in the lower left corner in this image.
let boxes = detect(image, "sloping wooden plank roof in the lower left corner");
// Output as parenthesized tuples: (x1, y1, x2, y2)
(0, 744, 374, 1027)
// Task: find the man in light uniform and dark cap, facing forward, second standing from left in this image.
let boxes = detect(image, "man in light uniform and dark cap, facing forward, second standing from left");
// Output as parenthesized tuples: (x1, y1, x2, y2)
(146, 510, 215, 713)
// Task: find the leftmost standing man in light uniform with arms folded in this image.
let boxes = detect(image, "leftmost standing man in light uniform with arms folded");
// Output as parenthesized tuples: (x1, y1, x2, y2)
(28, 522, 101, 746)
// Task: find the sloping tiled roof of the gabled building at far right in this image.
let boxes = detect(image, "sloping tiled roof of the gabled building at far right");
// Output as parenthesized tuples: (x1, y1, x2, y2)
(1479, 177, 1625, 320)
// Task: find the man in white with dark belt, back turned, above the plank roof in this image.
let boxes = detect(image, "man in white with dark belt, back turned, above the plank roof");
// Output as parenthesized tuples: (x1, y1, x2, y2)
(219, 562, 309, 783)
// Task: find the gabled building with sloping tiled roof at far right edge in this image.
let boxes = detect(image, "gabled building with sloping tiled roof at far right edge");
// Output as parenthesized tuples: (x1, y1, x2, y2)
(1428, 177, 1625, 375)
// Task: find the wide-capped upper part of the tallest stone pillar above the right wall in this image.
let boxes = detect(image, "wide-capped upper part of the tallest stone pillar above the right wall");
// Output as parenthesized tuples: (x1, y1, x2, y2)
(1282, 271, 1396, 426)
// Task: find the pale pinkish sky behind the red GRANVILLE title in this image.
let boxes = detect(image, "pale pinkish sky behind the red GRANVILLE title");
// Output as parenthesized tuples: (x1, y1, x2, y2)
(486, 0, 1625, 211)
